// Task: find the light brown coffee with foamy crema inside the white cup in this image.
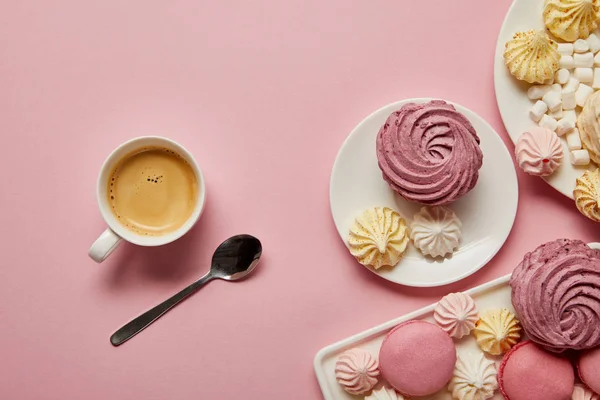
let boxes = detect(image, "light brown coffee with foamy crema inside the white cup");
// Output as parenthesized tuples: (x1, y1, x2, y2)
(107, 147, 198, 236)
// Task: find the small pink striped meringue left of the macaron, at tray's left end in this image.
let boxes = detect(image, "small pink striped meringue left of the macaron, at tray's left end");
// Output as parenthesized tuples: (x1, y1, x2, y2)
(335, 348, 379, 394)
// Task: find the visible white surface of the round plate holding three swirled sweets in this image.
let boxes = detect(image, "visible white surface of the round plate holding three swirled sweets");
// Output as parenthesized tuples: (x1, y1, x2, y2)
(329, 99, 519, 286)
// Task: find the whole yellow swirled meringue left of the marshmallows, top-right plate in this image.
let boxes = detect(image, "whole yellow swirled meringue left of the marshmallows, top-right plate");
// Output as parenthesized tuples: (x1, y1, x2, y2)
(504, 30, 560, 83)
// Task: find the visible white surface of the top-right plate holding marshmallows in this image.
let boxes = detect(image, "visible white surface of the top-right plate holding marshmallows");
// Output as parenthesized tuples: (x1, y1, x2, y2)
(494, 0, 588, 198)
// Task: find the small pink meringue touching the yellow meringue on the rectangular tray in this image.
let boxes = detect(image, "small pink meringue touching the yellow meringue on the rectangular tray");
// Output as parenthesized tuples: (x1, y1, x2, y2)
(433, 293, 478, 339)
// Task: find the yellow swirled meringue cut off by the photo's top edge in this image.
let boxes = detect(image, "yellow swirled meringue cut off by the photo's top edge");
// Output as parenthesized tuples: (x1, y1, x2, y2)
(544, 0, 600, 42)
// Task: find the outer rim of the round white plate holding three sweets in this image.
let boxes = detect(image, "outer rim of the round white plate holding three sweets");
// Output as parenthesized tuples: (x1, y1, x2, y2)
(329, 97, 519, 287)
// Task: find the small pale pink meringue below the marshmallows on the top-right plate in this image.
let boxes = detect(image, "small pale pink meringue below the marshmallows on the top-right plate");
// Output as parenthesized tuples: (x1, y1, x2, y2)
(515, 127, 563, 176)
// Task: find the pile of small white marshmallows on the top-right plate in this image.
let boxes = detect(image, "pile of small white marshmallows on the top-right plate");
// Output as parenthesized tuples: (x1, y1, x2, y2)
(527, 33, 600, 165)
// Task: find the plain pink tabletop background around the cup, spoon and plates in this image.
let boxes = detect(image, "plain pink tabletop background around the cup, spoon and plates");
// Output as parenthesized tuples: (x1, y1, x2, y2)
(0, 0, 598, 400)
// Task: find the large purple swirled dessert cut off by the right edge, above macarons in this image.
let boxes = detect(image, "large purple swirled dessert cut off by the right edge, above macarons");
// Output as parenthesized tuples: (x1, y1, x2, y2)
(510, 239, 600, 352)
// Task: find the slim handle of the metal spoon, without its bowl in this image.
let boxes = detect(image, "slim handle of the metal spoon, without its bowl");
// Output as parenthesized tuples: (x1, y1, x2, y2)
(110, 272, 214, 346)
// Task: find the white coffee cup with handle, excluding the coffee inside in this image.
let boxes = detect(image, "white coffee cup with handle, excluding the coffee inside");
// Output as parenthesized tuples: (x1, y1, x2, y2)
(88, 136, 206, 263)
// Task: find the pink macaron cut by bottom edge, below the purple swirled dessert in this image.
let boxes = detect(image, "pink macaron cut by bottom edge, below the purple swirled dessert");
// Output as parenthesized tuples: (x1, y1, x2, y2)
(498, 340, 575, 400)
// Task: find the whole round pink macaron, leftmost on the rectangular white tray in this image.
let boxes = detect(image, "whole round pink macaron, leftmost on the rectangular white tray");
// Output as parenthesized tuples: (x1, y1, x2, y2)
(379, 321, 456, 396)
